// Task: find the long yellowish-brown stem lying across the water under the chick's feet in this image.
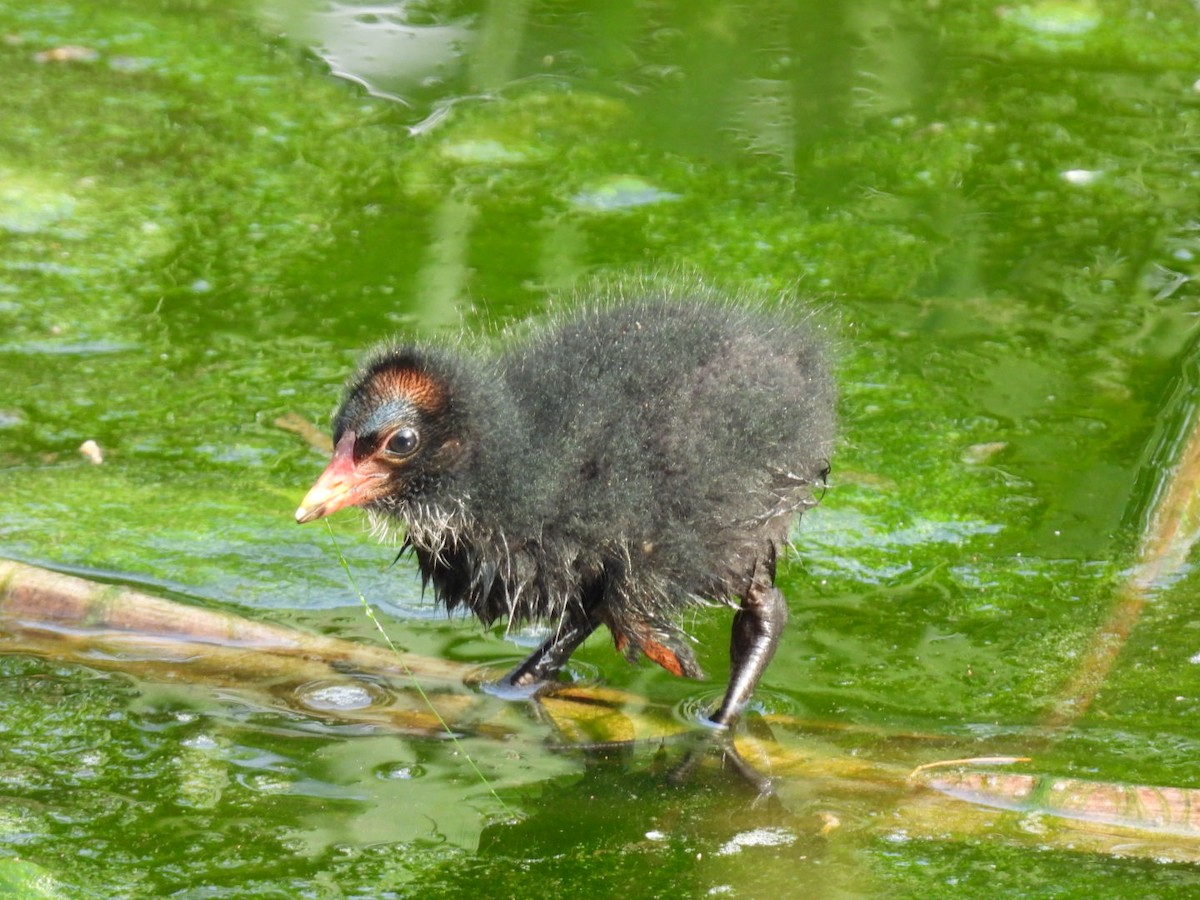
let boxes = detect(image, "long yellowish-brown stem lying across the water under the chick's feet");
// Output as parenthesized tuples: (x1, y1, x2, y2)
(7, 562, 1200, 863)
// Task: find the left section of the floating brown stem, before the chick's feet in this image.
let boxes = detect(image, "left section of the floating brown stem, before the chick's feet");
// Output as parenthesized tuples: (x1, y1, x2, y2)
(0, 560, 501, 736)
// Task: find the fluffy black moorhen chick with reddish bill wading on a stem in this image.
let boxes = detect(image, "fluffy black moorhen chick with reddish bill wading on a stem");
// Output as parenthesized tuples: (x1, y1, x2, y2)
(296, 290, 834, 726)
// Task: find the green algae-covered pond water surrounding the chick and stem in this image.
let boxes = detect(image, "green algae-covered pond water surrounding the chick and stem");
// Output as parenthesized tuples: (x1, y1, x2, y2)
(0, 0, 1200, 900)
